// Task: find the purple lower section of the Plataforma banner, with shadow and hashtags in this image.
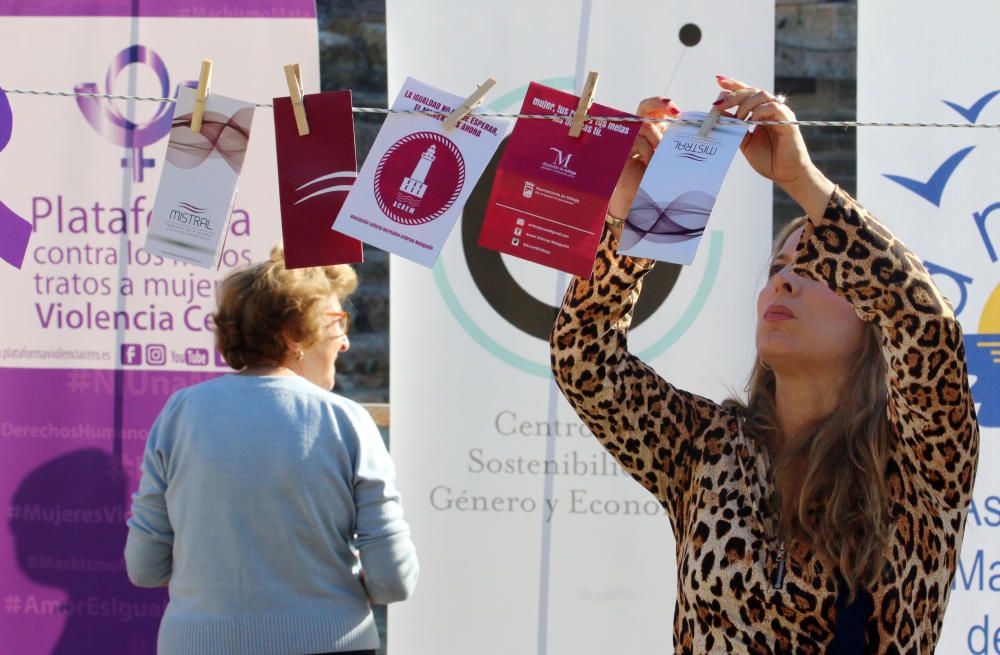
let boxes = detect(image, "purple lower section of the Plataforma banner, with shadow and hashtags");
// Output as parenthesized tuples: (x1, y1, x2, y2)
(0, 368, 219, 655)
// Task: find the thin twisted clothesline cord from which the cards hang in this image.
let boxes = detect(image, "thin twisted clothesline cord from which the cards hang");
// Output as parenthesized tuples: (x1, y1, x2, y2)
(3, 89, 1000, 129)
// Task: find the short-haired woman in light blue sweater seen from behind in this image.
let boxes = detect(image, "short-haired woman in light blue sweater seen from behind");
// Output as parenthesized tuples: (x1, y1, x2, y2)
(125, 249, 418, 655)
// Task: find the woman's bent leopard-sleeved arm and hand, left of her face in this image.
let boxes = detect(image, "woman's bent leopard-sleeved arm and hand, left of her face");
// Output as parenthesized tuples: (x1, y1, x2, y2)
(550, 98, 721, 533)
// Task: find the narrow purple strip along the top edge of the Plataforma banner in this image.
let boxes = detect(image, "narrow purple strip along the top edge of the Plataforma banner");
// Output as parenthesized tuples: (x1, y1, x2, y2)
(0, 0, 316, 18)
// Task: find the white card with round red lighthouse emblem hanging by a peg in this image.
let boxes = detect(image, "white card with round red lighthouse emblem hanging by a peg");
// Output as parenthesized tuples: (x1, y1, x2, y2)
(333, 78, 510, 267)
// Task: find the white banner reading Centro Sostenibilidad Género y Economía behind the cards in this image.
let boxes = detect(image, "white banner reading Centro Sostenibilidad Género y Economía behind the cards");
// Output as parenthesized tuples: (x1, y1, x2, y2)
(387, 0, 774, 655)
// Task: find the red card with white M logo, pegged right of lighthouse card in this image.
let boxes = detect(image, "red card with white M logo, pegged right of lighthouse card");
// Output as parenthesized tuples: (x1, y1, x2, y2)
(479, 82, 640, 276)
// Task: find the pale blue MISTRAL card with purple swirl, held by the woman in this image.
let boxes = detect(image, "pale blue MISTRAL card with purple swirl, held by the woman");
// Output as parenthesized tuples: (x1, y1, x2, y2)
(618, 112, 748, 264)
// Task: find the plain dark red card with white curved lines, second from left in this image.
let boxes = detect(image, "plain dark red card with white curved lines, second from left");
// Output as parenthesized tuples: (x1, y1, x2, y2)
(274, 91, 364, 268)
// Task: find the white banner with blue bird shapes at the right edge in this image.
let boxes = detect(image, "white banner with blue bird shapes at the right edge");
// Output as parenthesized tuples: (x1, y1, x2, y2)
(858, 0, 1000, 654)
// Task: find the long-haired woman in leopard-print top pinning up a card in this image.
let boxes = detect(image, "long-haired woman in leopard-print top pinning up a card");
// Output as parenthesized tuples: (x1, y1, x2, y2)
(551, 78, 979, 654)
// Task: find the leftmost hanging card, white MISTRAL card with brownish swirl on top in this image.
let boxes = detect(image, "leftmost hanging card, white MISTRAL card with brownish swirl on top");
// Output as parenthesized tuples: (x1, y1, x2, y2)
(145, 87, 254, 268)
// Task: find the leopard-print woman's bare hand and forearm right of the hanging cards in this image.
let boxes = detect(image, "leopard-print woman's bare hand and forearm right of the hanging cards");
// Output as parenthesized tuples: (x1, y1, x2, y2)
(715, 77, 834, 218)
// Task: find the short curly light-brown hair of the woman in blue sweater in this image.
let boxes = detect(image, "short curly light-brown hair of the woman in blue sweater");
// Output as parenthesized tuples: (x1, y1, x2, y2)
(212, 246, 358, 370)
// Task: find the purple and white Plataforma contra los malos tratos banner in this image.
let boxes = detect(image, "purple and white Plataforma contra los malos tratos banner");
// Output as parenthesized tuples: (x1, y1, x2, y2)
(0, 5, 318, 655)
